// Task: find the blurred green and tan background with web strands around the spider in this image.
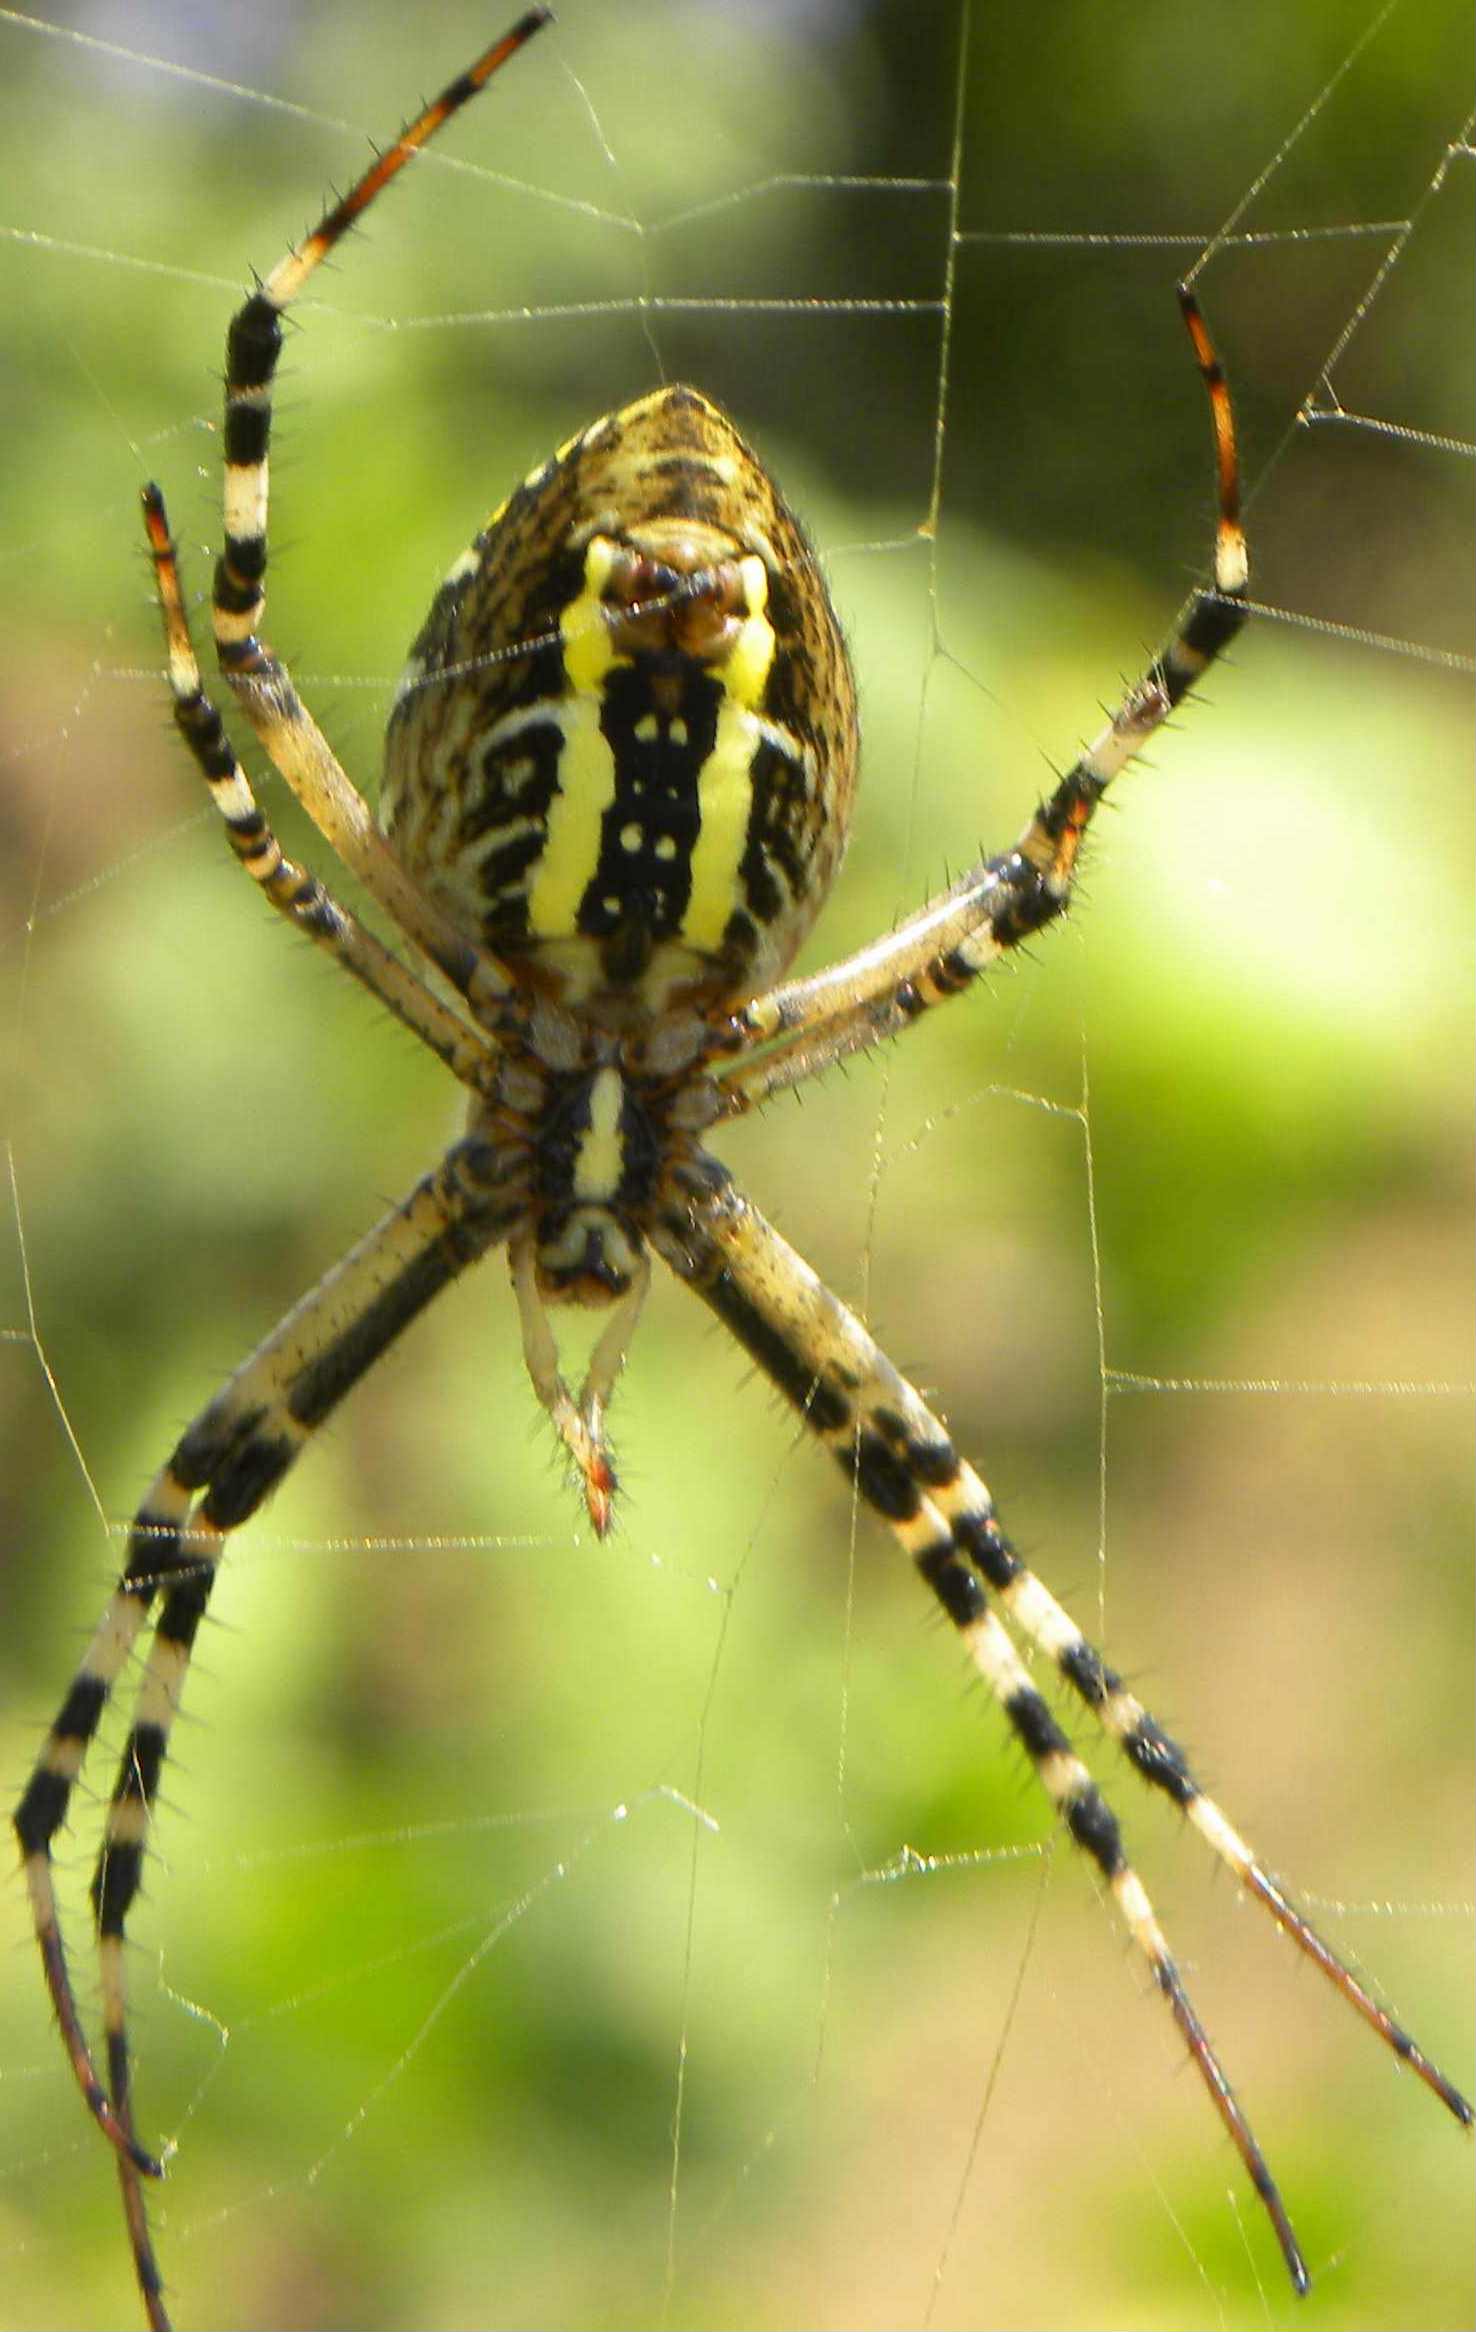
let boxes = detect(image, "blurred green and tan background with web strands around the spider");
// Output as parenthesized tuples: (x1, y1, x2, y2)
(0, 0, 1474, 2327)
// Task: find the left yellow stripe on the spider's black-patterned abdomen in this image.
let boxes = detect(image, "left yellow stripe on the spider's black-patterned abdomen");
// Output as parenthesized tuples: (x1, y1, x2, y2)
(527, 534, 630, 940)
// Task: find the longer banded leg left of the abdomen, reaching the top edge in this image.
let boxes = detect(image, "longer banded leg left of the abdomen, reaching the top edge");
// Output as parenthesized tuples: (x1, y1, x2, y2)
(212, 7, 550, 1026)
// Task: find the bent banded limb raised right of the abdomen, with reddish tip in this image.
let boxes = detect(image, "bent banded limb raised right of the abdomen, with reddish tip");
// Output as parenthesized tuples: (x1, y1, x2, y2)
(714, 287, 1250, 1115)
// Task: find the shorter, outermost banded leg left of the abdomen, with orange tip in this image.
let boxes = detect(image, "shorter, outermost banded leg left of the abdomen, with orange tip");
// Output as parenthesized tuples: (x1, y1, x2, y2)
(142, 485, 497, 1087)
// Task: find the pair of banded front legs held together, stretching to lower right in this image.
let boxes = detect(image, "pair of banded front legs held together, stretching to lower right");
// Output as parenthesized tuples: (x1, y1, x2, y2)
(658, 1189, 1471, 2290)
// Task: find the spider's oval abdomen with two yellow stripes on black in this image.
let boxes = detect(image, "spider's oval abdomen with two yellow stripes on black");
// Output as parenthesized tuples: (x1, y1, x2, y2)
(380, 387, 856, 1021)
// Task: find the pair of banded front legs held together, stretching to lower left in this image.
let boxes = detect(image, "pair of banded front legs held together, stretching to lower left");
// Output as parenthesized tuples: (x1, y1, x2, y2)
(14, 1140, 515, 2325)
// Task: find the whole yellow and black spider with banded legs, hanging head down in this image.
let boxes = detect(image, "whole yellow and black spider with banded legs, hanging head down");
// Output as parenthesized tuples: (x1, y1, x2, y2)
(14, 7, 1471, 2327)
